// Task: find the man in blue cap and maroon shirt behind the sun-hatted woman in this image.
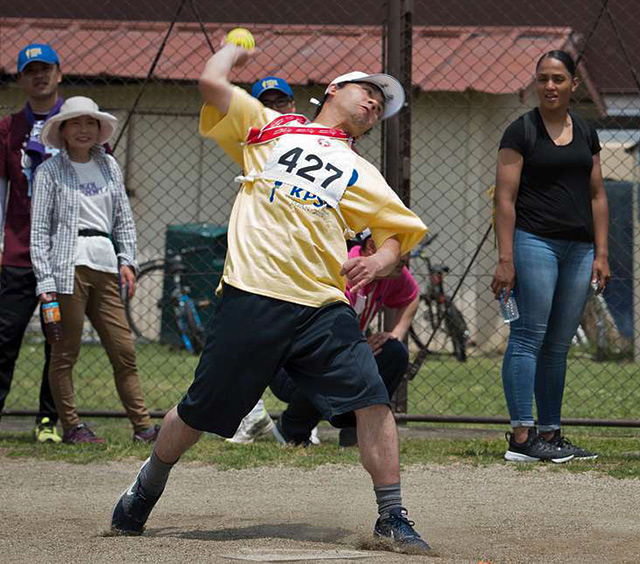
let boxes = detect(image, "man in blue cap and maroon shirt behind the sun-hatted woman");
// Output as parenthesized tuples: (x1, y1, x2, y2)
(0, 44, 62, 443)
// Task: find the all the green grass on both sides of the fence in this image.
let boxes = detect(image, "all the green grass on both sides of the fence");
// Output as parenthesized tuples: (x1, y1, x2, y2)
(0, 342, 640, 478)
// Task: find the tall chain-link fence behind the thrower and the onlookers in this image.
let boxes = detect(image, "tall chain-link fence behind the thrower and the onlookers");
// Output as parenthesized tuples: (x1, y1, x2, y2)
(0, 0, 640, 424)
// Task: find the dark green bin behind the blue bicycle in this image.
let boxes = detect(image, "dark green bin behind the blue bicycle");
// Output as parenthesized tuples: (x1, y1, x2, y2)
(160, 223, 227, 348)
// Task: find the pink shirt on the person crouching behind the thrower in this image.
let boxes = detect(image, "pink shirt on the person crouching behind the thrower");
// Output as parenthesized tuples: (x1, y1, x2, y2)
(345, 246, 420, 331)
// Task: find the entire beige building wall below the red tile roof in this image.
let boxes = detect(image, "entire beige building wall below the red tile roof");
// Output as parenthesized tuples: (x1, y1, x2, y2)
(0, 84, 604, 349)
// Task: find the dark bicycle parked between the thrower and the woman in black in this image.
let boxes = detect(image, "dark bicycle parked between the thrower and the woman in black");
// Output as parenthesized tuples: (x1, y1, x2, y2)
(409, 233, 469, 362)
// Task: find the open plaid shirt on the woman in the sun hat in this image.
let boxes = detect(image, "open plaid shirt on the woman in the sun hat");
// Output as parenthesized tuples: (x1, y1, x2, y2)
(30, 146, 138, 295)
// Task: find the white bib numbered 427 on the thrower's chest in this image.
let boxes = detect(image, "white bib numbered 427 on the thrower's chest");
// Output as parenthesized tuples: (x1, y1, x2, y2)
(260, 134, 356, 208)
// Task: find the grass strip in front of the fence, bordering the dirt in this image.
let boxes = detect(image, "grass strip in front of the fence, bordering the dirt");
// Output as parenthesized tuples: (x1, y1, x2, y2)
(0, 419, 640, 479)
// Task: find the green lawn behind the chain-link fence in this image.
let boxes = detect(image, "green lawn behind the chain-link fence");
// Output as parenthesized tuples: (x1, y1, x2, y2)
(6, 342, 640, 419)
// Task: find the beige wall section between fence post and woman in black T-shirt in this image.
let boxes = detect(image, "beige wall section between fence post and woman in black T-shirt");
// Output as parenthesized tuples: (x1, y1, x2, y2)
(411, 92, 533, 349)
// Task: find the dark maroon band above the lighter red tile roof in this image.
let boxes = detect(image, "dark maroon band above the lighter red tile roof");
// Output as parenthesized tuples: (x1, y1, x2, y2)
(0, 0, 640, 95)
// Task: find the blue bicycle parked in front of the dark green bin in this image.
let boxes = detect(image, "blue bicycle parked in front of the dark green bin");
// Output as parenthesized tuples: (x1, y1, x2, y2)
(125, 247, 212, 354)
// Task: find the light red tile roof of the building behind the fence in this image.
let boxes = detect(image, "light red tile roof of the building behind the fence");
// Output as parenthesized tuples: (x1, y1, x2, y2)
(0, 18, 592, 94)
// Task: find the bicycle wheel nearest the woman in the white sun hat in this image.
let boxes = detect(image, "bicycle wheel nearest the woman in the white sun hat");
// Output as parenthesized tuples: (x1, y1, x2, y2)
(125, 259, 165, 343)
